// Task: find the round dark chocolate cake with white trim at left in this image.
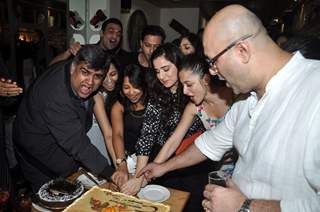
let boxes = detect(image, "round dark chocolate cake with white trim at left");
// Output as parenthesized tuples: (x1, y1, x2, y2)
(38, 179, 84, 209)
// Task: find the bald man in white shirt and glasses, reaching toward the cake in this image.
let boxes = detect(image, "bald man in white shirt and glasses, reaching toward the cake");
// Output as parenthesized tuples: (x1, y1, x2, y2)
(139, 5, 320, 212)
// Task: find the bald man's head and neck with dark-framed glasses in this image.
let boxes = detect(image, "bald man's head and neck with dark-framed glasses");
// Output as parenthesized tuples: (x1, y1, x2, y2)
(203, 5, 290, 96)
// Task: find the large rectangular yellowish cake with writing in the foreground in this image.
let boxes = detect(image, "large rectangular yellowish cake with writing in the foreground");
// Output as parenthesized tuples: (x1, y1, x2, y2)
(64, 186, 170, 212)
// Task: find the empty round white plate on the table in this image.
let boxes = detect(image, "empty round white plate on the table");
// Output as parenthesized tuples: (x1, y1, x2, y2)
(137, 185, 170, 202)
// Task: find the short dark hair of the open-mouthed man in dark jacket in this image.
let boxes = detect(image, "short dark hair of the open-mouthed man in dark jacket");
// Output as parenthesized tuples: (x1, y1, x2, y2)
(72, 44, 111, 74)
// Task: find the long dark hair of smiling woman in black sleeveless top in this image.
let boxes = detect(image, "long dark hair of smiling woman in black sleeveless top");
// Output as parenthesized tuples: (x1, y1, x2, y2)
(119, 64, 148, 112)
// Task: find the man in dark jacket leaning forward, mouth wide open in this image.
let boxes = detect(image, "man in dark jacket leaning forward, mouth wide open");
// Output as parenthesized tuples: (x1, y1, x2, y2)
(14, 45, 113, 191)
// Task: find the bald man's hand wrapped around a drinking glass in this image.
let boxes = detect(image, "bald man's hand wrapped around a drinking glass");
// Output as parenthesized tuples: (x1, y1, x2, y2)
(202, 179, 246, 212)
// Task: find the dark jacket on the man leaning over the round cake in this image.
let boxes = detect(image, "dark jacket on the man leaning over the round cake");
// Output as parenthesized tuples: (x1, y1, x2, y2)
(14, 62, 113, 188)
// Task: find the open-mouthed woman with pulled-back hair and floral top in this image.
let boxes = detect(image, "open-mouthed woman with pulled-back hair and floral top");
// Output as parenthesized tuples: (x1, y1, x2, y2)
(154, 55, 233, 163)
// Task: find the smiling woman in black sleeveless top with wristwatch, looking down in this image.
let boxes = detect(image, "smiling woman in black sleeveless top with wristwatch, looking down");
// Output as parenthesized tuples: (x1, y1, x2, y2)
(111, 65, 148, 186)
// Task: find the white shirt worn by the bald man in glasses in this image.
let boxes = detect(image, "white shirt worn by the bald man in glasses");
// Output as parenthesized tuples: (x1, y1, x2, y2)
(195, 52, 320, 212)
